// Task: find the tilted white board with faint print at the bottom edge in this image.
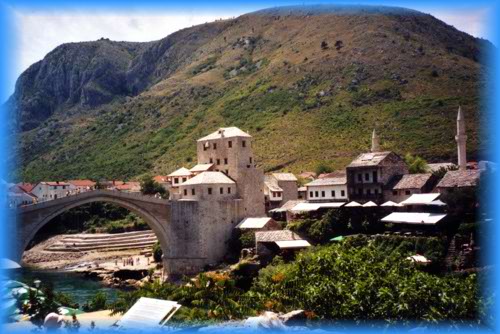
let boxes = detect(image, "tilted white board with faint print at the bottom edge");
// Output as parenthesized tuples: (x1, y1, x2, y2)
(118, 297, 181, 329)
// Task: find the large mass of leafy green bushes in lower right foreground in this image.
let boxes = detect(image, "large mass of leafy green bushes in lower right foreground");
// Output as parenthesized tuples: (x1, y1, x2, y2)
(252, 243, 480, 323)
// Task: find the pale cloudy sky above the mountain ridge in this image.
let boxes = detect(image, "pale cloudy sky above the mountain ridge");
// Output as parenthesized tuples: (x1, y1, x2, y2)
(2, 0, 496, 100)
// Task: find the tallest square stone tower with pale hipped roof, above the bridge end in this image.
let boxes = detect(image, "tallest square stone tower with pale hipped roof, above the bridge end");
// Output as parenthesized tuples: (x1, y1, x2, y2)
(197, 127, 265, 217)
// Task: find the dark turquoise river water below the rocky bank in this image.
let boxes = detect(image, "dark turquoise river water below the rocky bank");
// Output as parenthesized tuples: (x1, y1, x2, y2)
(9, 268, 118, 306)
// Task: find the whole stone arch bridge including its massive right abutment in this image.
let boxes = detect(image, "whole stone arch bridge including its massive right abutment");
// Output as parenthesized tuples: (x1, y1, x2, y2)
(12, 190, 240, 276)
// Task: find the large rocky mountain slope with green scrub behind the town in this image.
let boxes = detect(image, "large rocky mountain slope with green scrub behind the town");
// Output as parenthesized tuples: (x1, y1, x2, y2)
(8, 6, 490, 181)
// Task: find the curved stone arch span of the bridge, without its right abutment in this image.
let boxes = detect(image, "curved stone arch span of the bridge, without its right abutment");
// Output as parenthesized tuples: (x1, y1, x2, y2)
(17, 190, 172, 274)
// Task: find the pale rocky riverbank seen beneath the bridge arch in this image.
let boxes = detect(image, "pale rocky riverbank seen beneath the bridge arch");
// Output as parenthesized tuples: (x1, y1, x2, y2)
(22, 235, 162, 288)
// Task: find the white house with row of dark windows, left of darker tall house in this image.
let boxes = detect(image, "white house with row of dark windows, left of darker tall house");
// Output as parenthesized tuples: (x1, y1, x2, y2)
(305, 176, 348, 202)
